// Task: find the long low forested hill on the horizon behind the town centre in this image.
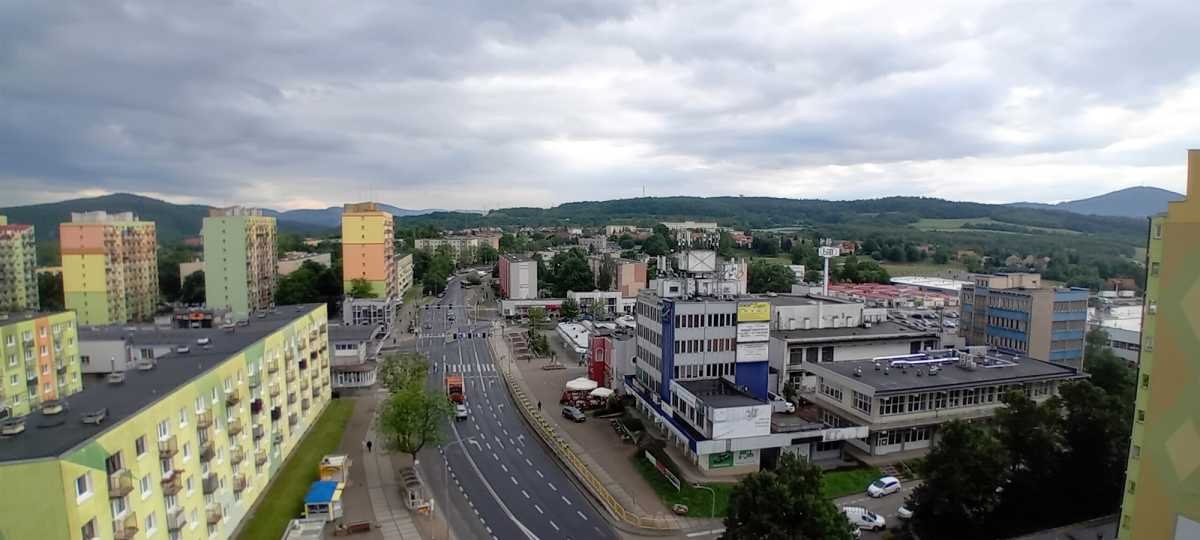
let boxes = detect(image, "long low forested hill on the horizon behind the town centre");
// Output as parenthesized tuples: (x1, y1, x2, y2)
(400, 197, 1146, 244)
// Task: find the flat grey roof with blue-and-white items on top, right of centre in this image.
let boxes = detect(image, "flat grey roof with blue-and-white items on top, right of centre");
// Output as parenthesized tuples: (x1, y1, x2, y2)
(805, 352, 1086, 395)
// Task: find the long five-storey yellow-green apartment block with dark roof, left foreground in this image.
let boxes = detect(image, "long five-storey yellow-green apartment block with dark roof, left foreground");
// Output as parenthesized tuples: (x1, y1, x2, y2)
(0, 304, 331, 540)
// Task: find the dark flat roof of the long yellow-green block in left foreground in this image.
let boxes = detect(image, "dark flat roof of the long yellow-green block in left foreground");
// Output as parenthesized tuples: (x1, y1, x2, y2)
(0, 304, 323, 462)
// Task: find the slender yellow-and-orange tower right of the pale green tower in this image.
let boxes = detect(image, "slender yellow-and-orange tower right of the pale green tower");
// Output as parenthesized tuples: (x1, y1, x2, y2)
(342, 203, 398, 299)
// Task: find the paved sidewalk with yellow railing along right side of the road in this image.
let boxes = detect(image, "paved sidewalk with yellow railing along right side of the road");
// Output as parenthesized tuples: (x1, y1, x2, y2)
(493, 326, 691, 535)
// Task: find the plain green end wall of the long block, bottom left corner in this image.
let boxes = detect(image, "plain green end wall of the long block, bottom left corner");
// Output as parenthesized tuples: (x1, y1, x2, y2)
(0, 460, 69, 540)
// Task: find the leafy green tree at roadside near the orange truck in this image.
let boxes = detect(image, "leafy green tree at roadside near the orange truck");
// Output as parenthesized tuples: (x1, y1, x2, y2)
(376, 383, 454, 461)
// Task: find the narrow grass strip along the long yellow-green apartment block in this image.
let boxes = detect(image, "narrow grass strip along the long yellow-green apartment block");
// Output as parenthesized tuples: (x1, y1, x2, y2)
(238, 400, 354, 540)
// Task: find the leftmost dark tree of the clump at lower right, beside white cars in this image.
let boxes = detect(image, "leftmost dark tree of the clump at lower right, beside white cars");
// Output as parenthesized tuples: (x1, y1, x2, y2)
(908, 420, 1008, 539)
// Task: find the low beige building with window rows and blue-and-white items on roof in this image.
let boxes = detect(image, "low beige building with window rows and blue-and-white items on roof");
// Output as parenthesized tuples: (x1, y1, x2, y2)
(806, 347, 1086, 456)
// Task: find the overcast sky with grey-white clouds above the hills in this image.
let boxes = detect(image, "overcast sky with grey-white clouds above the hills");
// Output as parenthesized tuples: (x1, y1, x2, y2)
(0, 0, 1200, 209)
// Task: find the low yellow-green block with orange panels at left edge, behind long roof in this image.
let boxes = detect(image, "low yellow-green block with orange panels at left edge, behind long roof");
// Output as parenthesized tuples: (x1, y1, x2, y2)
(0, 311, 83, 419)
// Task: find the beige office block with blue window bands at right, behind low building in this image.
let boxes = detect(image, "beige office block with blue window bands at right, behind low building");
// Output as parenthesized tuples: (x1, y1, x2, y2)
(959, 272, 1088, 368)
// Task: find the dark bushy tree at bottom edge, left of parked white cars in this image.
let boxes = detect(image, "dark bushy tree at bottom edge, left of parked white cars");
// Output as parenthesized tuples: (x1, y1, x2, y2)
(721, 452, 853, 540)
